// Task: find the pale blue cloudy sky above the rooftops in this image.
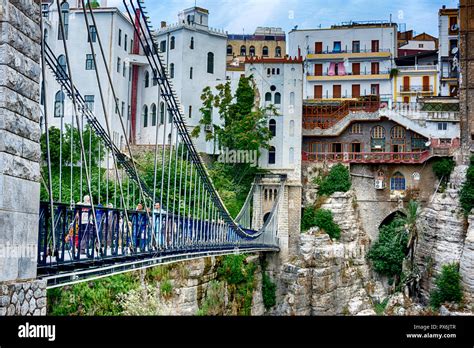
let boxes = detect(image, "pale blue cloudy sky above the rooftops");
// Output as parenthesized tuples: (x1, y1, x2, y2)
(108, 0, 459, 36)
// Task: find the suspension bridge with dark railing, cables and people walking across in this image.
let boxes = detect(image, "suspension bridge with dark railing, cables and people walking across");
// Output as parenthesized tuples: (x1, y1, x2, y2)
(37, 0, 286, 287)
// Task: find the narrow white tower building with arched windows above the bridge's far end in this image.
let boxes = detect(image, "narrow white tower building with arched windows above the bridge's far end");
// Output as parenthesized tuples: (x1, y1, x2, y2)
(245, 57, 303, 181)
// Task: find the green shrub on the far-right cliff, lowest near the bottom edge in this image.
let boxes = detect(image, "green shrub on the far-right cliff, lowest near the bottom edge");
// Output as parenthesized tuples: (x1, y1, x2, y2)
(430, 263, 462, 308)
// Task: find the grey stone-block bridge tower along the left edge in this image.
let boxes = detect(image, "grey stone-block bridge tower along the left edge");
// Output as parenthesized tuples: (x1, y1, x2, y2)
(0, 0, 46, 316)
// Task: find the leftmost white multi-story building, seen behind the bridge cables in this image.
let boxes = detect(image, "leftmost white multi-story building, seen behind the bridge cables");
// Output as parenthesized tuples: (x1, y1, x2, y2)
(42, 1, 141, 146)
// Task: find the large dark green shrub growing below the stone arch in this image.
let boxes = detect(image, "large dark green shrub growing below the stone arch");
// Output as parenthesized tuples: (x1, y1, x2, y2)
(367, 218, 408, 277)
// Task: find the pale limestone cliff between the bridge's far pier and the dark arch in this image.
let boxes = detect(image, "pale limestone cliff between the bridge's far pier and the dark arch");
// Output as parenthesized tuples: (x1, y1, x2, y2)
(275, 192, 386, 315)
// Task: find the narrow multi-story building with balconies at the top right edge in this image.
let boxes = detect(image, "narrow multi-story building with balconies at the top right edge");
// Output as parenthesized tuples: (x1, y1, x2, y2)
(438, 6, 460, 97)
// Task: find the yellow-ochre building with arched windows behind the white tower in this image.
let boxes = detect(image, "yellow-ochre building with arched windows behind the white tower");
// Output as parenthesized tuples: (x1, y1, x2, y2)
(227, 27, 286, 70)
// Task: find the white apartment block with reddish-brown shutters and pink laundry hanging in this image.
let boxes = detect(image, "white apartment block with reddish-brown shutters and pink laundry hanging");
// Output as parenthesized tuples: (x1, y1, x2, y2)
(288, 22, 397, 100)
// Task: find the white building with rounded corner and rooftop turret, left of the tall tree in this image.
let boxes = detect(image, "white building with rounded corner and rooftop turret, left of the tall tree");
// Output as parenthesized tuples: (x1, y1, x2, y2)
(152, 7, 227, 154)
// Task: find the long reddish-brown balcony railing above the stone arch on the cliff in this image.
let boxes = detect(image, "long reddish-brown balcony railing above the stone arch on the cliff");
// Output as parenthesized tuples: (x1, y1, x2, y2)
(302, 150, 431, 164)
